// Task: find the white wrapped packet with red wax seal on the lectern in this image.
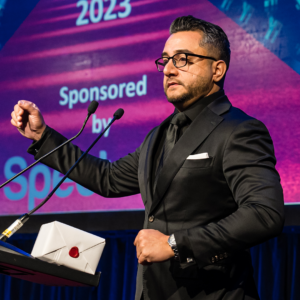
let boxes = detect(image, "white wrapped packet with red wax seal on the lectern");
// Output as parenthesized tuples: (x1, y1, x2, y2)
(31, 221, 105, 274)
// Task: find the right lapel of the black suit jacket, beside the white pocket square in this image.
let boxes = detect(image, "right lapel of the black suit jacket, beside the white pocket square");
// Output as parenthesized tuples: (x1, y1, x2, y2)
(148, 96, 231, 213)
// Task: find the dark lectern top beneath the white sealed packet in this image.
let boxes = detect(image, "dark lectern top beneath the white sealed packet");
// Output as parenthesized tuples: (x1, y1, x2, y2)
(0, 242, 100, 287)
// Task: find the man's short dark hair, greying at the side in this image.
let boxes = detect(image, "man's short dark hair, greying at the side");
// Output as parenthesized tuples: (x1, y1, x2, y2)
(170, 15, 230, 70)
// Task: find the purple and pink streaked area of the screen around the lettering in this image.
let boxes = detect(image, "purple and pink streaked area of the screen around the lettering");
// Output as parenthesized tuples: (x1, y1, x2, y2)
(0, 0, 300, 214)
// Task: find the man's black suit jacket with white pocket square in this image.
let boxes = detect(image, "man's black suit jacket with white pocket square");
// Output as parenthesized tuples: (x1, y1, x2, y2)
(29, 96, 284, 300)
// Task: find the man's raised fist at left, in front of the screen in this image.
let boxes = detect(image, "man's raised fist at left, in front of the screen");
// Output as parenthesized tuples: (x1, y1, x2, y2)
(10, 100, 46, 141)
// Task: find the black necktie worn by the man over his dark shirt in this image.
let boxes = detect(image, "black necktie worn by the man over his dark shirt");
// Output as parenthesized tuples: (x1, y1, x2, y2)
(153, 113, 188, 191)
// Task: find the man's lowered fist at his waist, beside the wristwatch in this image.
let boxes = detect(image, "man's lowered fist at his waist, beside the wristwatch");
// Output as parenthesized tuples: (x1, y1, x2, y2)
(134, 229, 174, 265)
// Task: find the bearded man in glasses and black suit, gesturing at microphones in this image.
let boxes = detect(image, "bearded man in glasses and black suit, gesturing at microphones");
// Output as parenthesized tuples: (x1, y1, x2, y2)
(11, 16, 284, 300)
